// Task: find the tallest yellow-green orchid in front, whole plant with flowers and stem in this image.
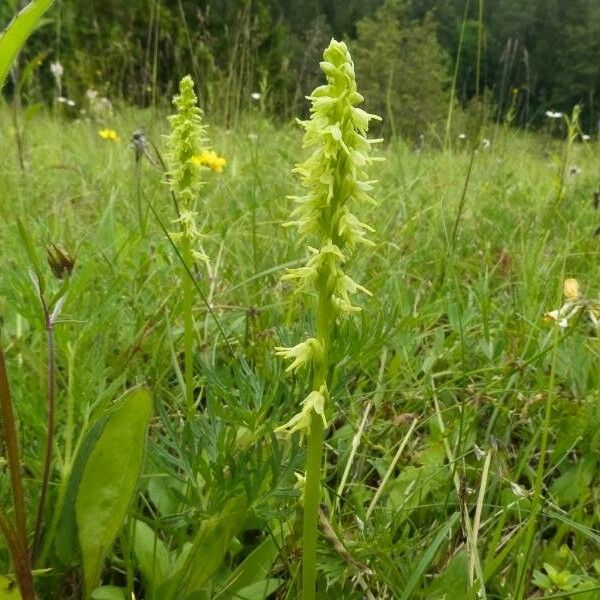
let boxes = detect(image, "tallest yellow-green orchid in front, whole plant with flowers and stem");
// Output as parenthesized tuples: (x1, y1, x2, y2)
(276, 40, 381, 599)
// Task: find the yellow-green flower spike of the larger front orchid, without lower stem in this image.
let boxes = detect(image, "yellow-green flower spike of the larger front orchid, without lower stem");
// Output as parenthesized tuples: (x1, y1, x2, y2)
(276, 40, 381, 430)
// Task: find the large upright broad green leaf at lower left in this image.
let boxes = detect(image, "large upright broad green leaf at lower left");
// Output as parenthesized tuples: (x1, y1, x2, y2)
(75, 388, 152, 598)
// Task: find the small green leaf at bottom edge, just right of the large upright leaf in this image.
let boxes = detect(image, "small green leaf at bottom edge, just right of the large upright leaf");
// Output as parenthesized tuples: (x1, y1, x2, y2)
(133, 521, 172, 600)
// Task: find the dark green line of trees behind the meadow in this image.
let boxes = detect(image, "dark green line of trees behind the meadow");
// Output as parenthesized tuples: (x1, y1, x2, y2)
(0, 0, 600, 136)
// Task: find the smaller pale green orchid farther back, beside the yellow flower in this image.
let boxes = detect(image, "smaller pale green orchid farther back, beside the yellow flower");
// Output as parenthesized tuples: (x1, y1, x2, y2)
(167, 75, 219, 412)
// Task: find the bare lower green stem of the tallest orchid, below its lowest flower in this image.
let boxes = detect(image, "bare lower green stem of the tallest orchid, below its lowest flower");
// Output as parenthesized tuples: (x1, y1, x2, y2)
(302, 411, 324, 600)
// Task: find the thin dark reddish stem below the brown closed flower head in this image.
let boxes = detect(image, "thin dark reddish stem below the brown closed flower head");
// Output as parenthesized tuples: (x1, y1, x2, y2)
(31, 302, 56, 564)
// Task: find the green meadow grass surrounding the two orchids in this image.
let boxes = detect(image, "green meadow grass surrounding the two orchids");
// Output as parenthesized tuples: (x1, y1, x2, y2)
(0, 105, 600, 600)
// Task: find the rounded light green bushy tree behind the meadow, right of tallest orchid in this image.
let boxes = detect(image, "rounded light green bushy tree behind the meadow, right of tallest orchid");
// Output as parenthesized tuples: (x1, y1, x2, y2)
(353, 0, 449, 139)
